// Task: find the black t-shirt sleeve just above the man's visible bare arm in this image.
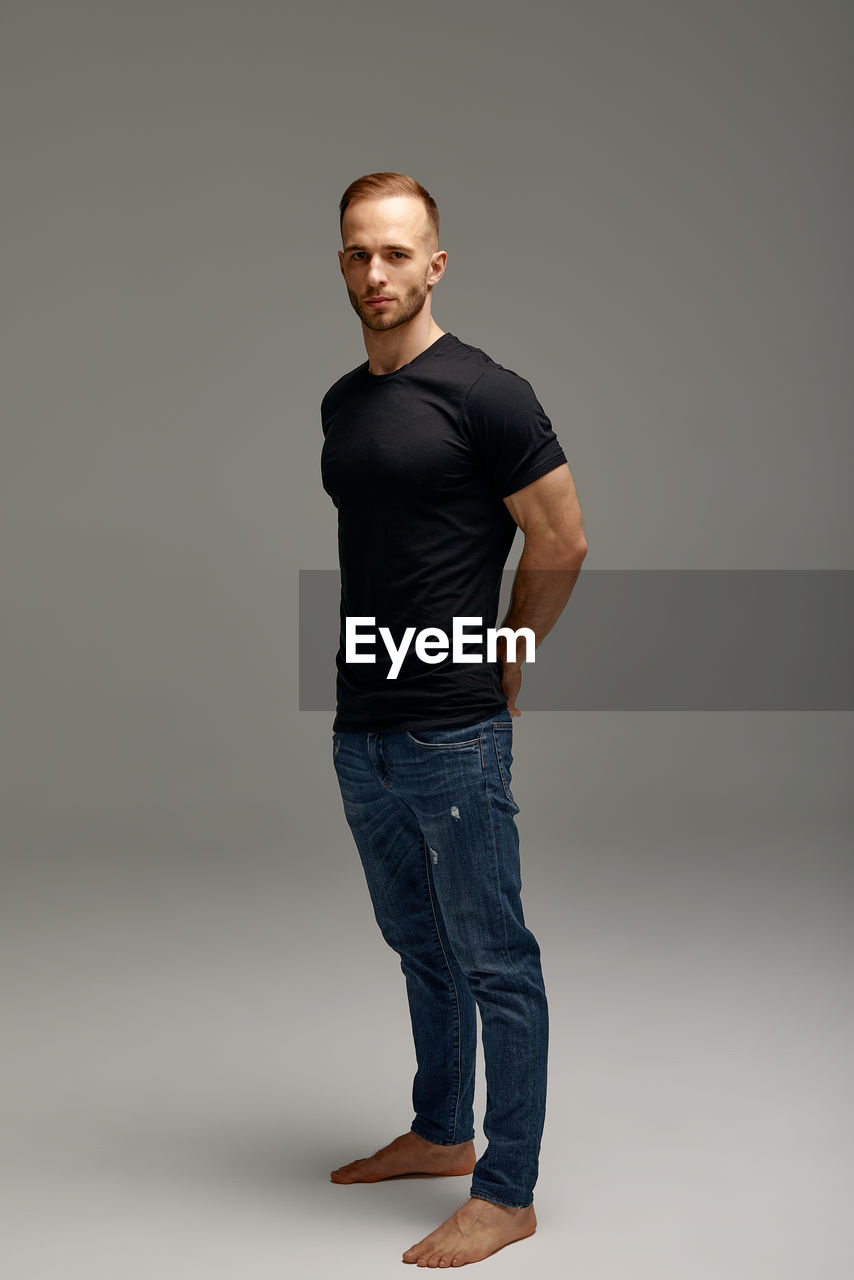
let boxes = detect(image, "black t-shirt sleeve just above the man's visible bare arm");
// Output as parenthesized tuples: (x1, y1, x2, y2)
(463, 366, 566, 498)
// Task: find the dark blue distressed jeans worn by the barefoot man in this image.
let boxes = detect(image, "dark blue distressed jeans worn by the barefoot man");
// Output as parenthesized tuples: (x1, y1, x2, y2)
(333, 709, 548, 1208)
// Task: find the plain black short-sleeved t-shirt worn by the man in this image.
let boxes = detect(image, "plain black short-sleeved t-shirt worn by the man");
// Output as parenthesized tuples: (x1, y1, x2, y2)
(320, 333, 566, 732)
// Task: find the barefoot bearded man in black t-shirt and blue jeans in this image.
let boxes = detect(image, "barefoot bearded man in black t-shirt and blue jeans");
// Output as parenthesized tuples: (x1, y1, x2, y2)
(321, 173, 586, 1267)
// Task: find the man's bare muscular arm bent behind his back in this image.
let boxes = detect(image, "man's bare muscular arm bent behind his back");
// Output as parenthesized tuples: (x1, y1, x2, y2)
(498, 463, 588, 716)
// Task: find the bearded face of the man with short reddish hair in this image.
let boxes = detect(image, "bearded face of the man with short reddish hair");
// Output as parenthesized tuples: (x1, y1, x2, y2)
(338, 196, 444, 333)
